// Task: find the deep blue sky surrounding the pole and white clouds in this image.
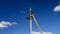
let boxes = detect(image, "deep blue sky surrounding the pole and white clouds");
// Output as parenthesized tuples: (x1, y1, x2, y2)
(0, 0, 60, 34)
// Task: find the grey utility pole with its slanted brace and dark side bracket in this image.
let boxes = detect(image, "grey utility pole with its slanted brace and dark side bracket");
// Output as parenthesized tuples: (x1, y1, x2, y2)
(26, 8, 43, 34)
